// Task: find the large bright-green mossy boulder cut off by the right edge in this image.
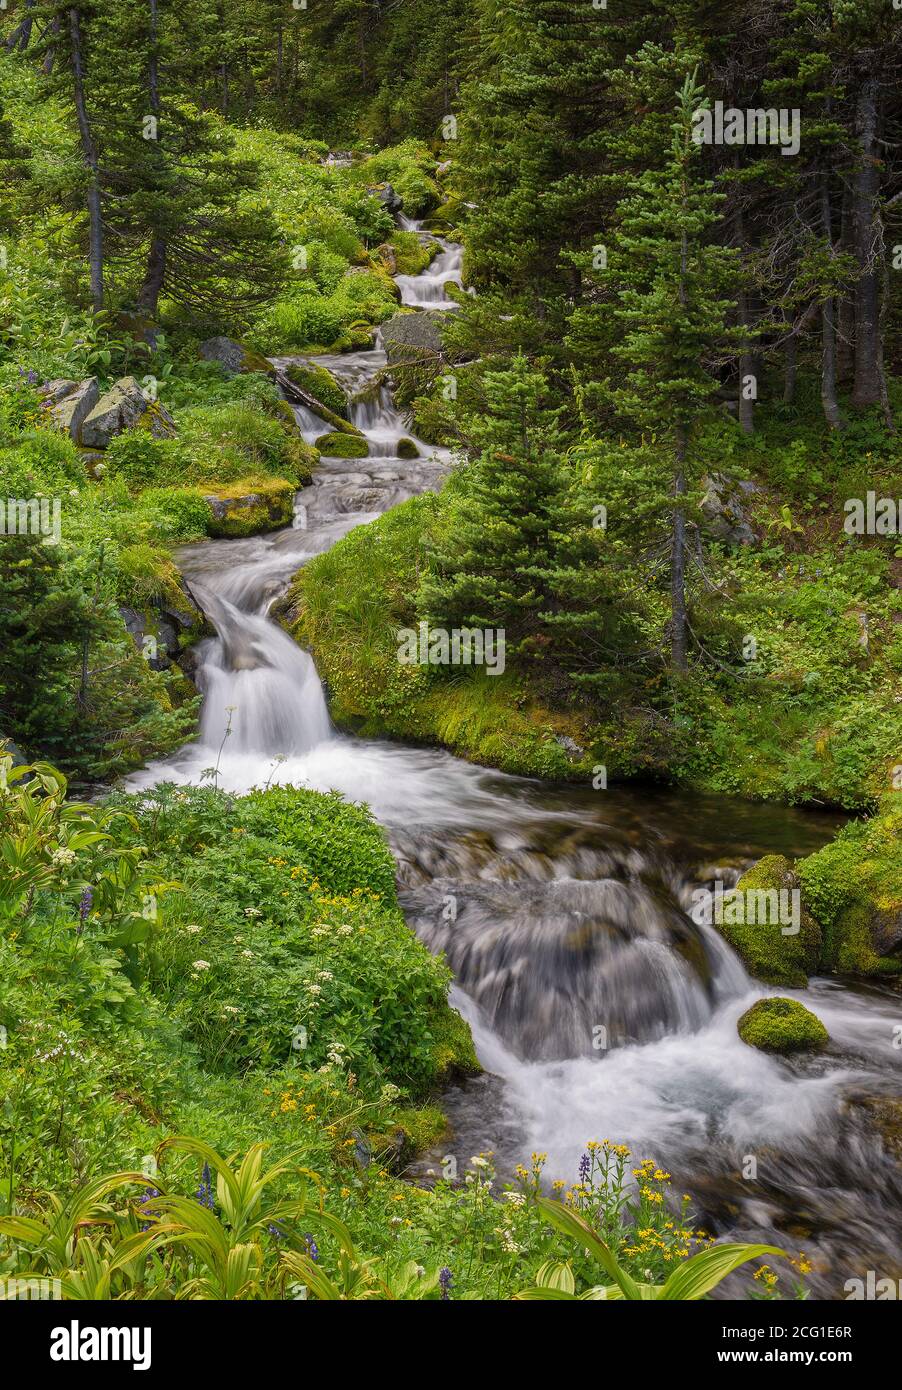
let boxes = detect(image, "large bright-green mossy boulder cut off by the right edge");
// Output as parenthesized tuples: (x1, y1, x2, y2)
(798, 792, 902, 974)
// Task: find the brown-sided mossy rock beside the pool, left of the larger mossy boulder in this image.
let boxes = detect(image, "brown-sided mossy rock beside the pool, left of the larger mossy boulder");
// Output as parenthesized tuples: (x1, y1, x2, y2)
(714, 855, 821, 988)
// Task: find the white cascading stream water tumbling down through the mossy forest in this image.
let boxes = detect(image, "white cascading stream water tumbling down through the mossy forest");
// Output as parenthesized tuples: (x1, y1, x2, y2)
(132, 224, 902, 1297)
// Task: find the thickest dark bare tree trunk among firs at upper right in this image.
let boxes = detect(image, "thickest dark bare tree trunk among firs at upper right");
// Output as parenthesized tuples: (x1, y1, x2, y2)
(852, 76, 884, 406)
